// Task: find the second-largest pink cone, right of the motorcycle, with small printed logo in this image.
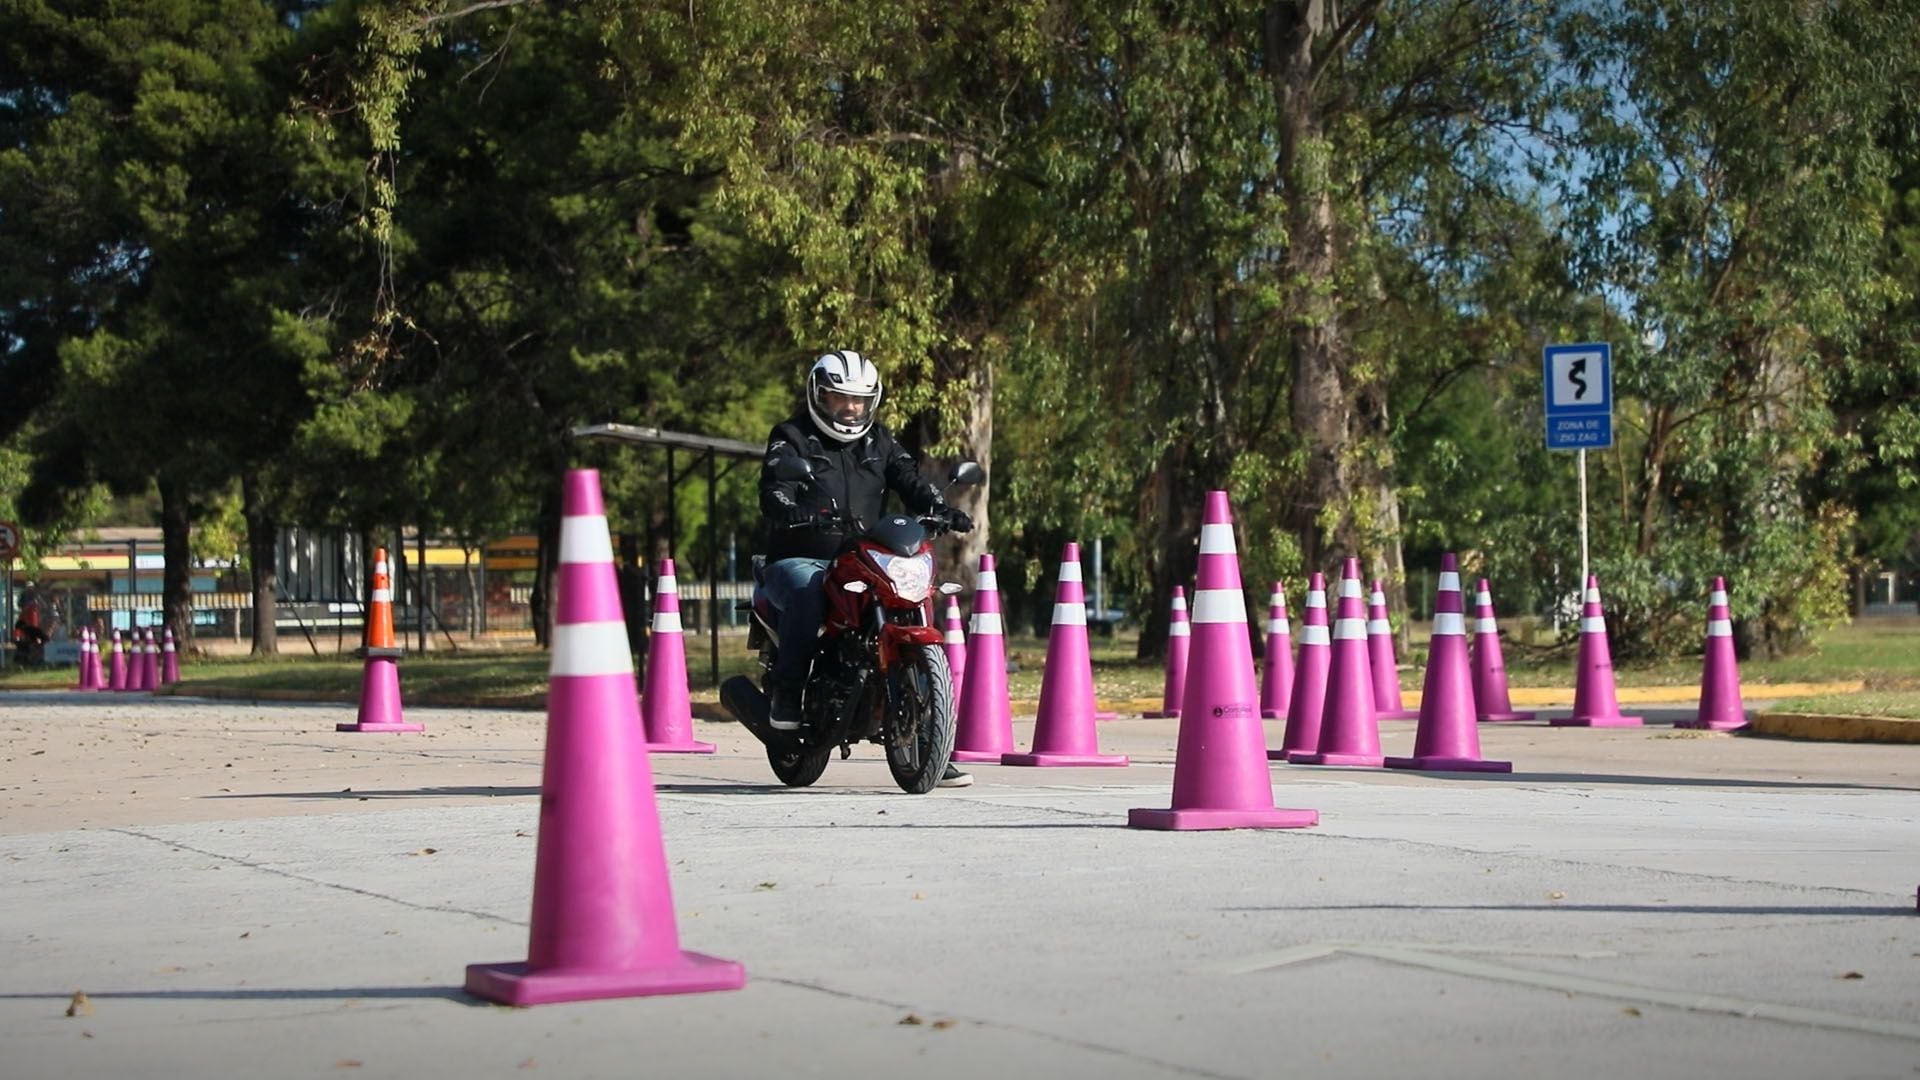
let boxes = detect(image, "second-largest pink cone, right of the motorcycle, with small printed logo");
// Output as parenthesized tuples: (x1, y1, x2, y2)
(1127, 492, 1319, 830)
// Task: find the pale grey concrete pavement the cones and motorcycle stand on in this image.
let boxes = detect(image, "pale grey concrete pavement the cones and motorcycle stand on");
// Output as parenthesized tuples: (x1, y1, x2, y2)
(0, 694, 1920, 1078)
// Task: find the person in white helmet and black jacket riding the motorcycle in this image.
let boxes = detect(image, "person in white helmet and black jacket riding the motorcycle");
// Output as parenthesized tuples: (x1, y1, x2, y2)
(760, 350, 973, 786)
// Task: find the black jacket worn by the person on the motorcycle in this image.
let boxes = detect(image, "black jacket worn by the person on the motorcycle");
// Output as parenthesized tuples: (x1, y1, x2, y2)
(760, 413, 941, 561)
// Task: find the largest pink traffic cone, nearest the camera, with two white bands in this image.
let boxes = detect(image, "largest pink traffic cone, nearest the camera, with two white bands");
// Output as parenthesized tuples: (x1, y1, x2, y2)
(467, 469, 747, 1005)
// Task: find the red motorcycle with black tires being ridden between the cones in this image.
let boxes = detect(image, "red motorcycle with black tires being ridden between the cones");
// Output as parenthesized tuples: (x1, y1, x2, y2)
(720, 459, 985, 796)
